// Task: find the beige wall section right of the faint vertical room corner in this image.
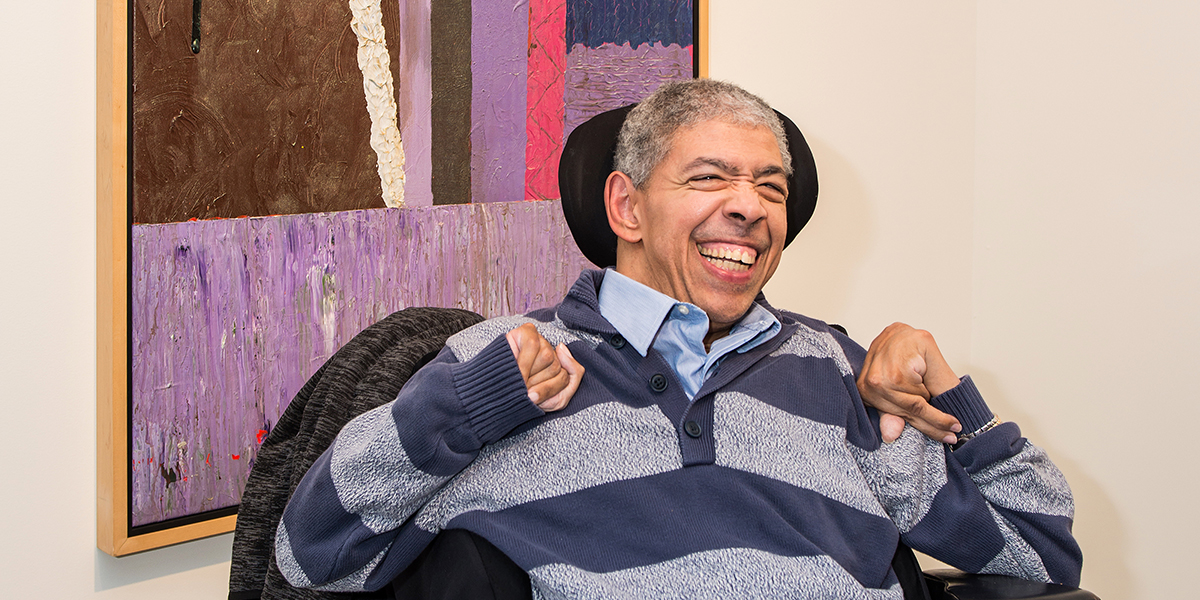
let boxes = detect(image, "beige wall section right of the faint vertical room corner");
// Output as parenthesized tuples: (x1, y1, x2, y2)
(971, 1, 1200, 599)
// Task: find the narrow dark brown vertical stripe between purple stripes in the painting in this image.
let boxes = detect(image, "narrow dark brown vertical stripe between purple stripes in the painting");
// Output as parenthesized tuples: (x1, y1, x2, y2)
(430, 0, 470, 204)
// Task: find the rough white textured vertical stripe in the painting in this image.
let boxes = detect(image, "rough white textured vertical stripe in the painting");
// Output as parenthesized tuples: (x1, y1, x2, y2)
(350, 0, 404, 208)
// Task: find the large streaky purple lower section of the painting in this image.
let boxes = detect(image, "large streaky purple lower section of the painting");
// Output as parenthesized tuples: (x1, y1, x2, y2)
(131, 202, 589, 526)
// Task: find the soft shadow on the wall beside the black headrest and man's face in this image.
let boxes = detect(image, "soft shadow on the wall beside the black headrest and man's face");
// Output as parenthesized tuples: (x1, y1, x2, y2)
(766, 138, 877, 324)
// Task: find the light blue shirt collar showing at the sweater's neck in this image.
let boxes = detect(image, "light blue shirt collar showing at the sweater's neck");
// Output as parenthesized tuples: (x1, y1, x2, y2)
(599, 269, 782, 398)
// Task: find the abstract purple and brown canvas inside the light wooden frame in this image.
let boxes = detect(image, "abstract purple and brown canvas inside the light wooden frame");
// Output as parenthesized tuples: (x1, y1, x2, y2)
(103, 0, 700, 552)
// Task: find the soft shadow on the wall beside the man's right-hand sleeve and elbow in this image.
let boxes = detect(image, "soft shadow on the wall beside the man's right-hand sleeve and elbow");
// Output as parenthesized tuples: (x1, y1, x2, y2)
(961, 365, 1135, 598)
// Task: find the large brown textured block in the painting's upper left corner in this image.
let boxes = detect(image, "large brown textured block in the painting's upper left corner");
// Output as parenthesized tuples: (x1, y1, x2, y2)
(132, 0, 393, 223)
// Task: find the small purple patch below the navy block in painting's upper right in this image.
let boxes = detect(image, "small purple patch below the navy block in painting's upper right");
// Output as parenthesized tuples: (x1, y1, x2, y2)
(563, 43, 691, 140)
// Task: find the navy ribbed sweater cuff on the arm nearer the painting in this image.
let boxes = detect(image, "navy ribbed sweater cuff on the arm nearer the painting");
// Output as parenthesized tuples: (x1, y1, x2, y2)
(450, 336, 546, 444)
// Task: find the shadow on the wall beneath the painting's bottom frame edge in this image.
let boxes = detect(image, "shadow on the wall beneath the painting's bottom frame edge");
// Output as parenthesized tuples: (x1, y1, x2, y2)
(92, 533, 233, 592)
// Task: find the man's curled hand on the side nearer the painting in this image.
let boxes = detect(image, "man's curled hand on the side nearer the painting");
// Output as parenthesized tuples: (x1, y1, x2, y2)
(505, 323, 583, 413)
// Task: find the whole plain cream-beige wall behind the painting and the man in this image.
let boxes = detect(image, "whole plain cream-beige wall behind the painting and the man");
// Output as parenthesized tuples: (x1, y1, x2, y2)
(0, 0, 1200, 599)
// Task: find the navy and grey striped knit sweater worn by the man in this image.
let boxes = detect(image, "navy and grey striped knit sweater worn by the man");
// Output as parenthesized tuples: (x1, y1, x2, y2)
(276, 271, 1081, 599)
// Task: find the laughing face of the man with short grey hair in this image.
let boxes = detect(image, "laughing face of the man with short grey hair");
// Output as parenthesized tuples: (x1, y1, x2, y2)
(610, 121, 787, 342)
